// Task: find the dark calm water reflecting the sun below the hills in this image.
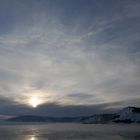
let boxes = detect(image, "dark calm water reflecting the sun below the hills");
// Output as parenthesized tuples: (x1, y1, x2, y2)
(0, 124, 140, 140)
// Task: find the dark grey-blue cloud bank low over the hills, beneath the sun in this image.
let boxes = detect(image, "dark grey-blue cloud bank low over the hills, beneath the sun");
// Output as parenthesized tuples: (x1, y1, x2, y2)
(0, 95, 140, 117)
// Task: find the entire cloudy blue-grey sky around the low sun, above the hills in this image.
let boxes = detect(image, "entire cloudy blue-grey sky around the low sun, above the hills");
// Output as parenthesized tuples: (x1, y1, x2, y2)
(0, 0, 140, 116)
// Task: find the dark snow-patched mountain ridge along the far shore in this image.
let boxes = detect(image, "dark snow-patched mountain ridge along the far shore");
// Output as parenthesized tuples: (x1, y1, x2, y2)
(8, 107, 140, 124)
